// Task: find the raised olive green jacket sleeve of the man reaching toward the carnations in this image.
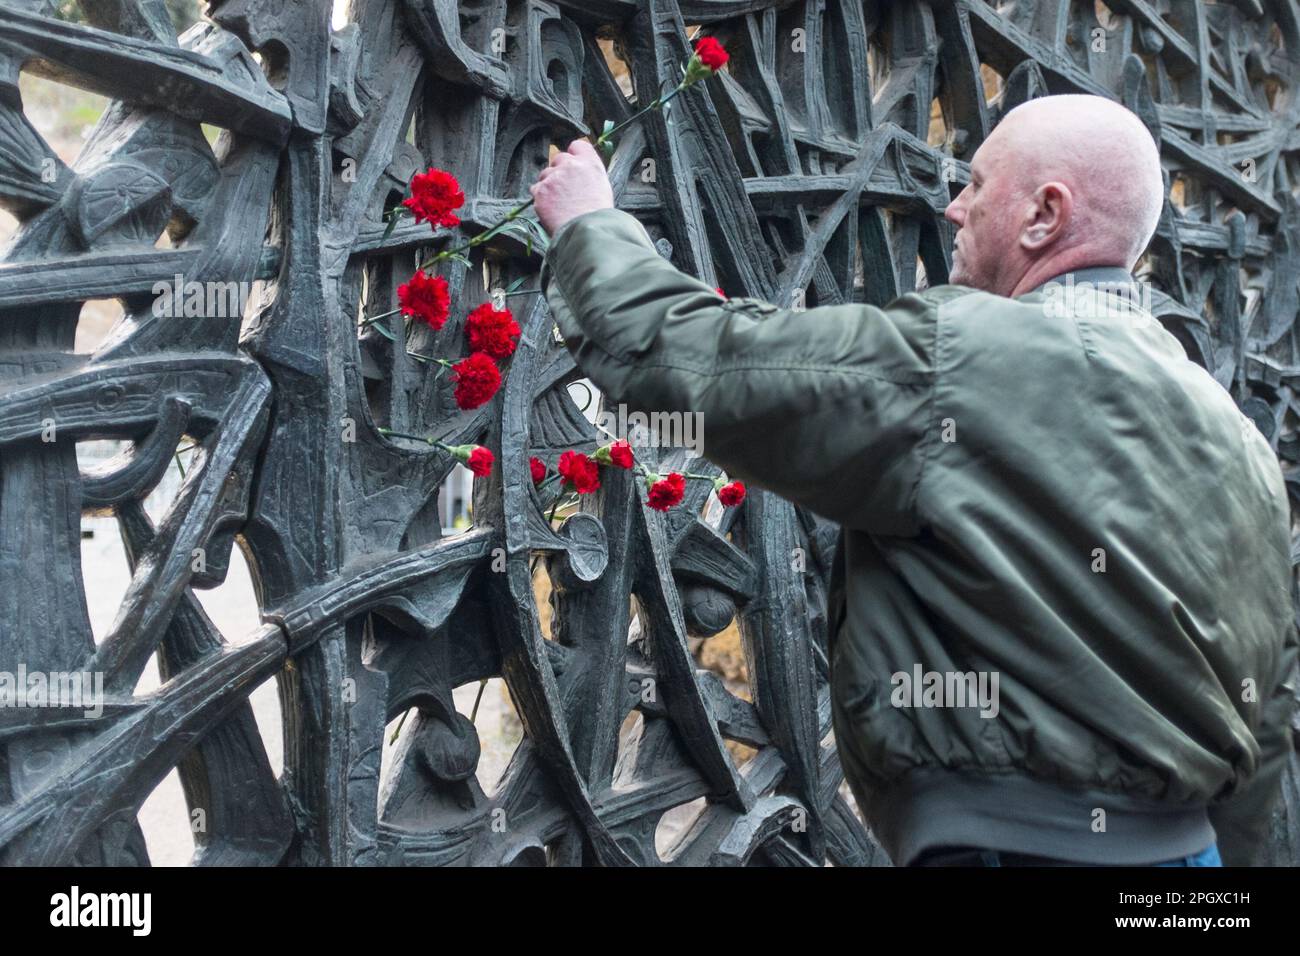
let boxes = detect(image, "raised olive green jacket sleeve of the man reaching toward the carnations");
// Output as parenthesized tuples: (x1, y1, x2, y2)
(542, 209, 952, 533)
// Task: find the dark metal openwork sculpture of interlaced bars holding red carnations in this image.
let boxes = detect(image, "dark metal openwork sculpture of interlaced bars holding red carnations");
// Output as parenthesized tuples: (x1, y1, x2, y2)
(0, 0, 1300, 865)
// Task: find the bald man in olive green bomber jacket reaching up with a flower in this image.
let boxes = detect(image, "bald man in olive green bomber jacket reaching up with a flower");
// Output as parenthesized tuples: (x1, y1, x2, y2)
(533, 96, 1297, 866)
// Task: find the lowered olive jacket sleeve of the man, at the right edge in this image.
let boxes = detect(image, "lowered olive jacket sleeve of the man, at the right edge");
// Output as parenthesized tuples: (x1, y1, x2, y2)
(1209, 626, 1300, 866)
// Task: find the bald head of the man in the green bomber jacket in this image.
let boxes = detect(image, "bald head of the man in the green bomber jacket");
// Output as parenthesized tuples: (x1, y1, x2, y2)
(945, 95, 1165, 295)
